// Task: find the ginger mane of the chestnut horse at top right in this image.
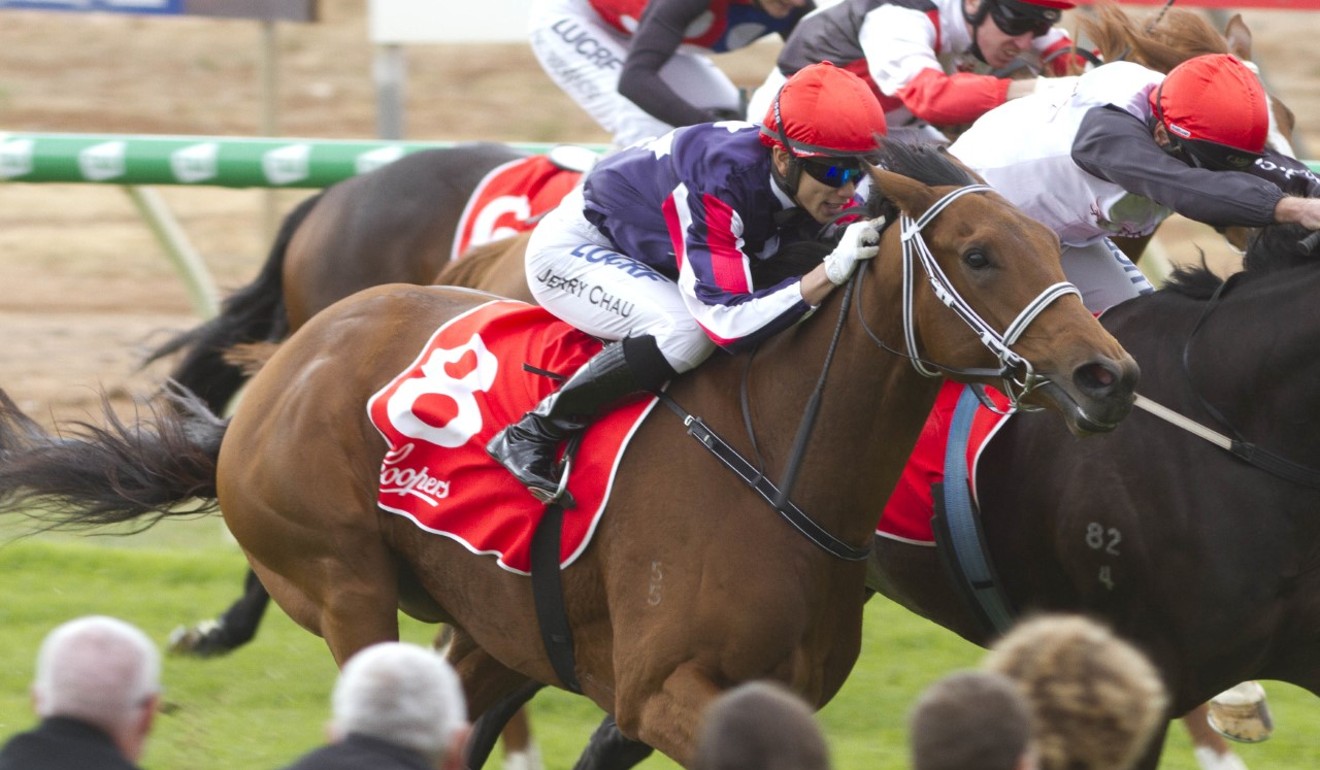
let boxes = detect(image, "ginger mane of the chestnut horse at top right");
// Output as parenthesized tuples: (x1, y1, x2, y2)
(1078, 1, 1229, 73)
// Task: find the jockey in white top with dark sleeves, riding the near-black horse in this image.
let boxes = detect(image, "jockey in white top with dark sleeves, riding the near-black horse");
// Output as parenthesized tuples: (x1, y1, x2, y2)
(949, 54, 1320, 312)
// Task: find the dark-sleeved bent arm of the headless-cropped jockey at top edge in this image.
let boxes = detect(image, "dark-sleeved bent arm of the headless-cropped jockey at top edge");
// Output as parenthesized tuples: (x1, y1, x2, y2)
(619, 0, 742, 125)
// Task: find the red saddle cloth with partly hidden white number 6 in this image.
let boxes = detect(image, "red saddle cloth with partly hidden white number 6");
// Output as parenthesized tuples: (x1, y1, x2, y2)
(449, 155, 582, 262)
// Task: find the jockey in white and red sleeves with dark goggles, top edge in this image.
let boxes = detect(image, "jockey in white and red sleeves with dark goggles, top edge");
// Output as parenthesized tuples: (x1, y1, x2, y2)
(748, 0, 1081, 144)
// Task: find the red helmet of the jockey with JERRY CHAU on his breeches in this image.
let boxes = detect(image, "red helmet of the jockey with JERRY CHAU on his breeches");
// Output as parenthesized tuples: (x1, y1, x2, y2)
(760, 62, 888, 157)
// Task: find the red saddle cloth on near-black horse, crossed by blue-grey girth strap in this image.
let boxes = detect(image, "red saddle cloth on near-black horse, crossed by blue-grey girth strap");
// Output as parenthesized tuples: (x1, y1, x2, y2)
(875, 380, 1008, 545)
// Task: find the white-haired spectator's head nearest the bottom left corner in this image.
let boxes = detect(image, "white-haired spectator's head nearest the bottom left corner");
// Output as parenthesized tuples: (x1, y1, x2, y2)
(32, 615, 161, 761)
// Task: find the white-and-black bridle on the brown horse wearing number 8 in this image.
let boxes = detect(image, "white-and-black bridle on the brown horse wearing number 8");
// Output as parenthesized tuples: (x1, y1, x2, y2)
(855, 185, 1081, 415)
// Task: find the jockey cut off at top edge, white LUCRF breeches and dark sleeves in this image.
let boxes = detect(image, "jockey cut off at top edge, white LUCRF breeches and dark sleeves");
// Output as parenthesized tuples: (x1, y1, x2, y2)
(529, 0, 813, 147)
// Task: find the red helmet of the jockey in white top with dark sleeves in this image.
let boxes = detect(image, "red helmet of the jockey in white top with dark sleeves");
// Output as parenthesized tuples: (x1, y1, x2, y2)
(1150, 54, 1270, 168)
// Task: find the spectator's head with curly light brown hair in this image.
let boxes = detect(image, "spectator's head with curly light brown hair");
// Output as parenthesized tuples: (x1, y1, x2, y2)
(985, 614, 1168, 770)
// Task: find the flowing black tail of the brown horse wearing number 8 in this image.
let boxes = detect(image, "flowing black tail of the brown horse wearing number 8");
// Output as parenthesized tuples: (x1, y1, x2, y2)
(0, 391, 227, 531)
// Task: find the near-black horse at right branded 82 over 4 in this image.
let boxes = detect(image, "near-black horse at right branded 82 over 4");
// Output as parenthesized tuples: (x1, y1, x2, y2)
(870, 226, 1320, 767)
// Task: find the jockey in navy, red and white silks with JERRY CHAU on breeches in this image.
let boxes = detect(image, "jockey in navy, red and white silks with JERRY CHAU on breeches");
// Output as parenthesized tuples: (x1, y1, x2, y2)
(487, 63, 886, 501)
